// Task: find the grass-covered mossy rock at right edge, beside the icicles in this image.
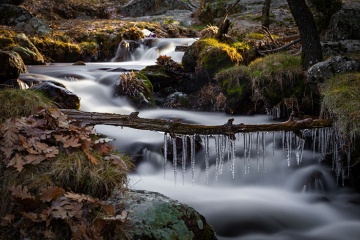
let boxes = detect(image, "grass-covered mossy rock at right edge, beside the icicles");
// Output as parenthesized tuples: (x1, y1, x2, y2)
(321, 72, 360, 191)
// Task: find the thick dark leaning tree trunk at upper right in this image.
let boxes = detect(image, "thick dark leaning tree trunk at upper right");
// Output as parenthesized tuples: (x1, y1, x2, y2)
(287, 0, 322, 69)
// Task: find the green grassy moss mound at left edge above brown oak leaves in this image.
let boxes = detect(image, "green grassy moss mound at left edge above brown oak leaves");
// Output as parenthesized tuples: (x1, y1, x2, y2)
(0, 89, 54, 123)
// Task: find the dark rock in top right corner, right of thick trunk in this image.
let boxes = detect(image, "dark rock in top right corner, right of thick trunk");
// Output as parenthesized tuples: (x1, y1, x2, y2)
(324, 2, 360, 41)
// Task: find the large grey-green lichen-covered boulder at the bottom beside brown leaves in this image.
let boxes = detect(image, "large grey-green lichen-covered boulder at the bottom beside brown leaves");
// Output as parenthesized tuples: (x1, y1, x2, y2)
(107, 190, 217, 240)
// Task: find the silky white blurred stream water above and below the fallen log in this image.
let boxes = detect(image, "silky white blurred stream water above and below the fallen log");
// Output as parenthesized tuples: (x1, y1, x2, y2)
(21, 40, 360, 240)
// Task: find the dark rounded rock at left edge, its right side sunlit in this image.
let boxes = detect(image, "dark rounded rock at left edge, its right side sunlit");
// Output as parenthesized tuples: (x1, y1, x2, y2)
(0, 51, 27, 83)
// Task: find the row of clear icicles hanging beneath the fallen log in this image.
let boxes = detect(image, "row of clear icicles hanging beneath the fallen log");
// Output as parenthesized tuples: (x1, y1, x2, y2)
(164, 128, 349, 184)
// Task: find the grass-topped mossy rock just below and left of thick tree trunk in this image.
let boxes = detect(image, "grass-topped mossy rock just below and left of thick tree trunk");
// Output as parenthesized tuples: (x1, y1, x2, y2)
(249, 53, 310, 118)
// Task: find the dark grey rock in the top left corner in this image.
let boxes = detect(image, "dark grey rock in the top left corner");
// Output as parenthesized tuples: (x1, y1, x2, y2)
(0, 4, 51, 36)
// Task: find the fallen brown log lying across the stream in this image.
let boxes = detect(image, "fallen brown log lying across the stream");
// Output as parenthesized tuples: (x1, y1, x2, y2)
(61, 109, 332, 136)
